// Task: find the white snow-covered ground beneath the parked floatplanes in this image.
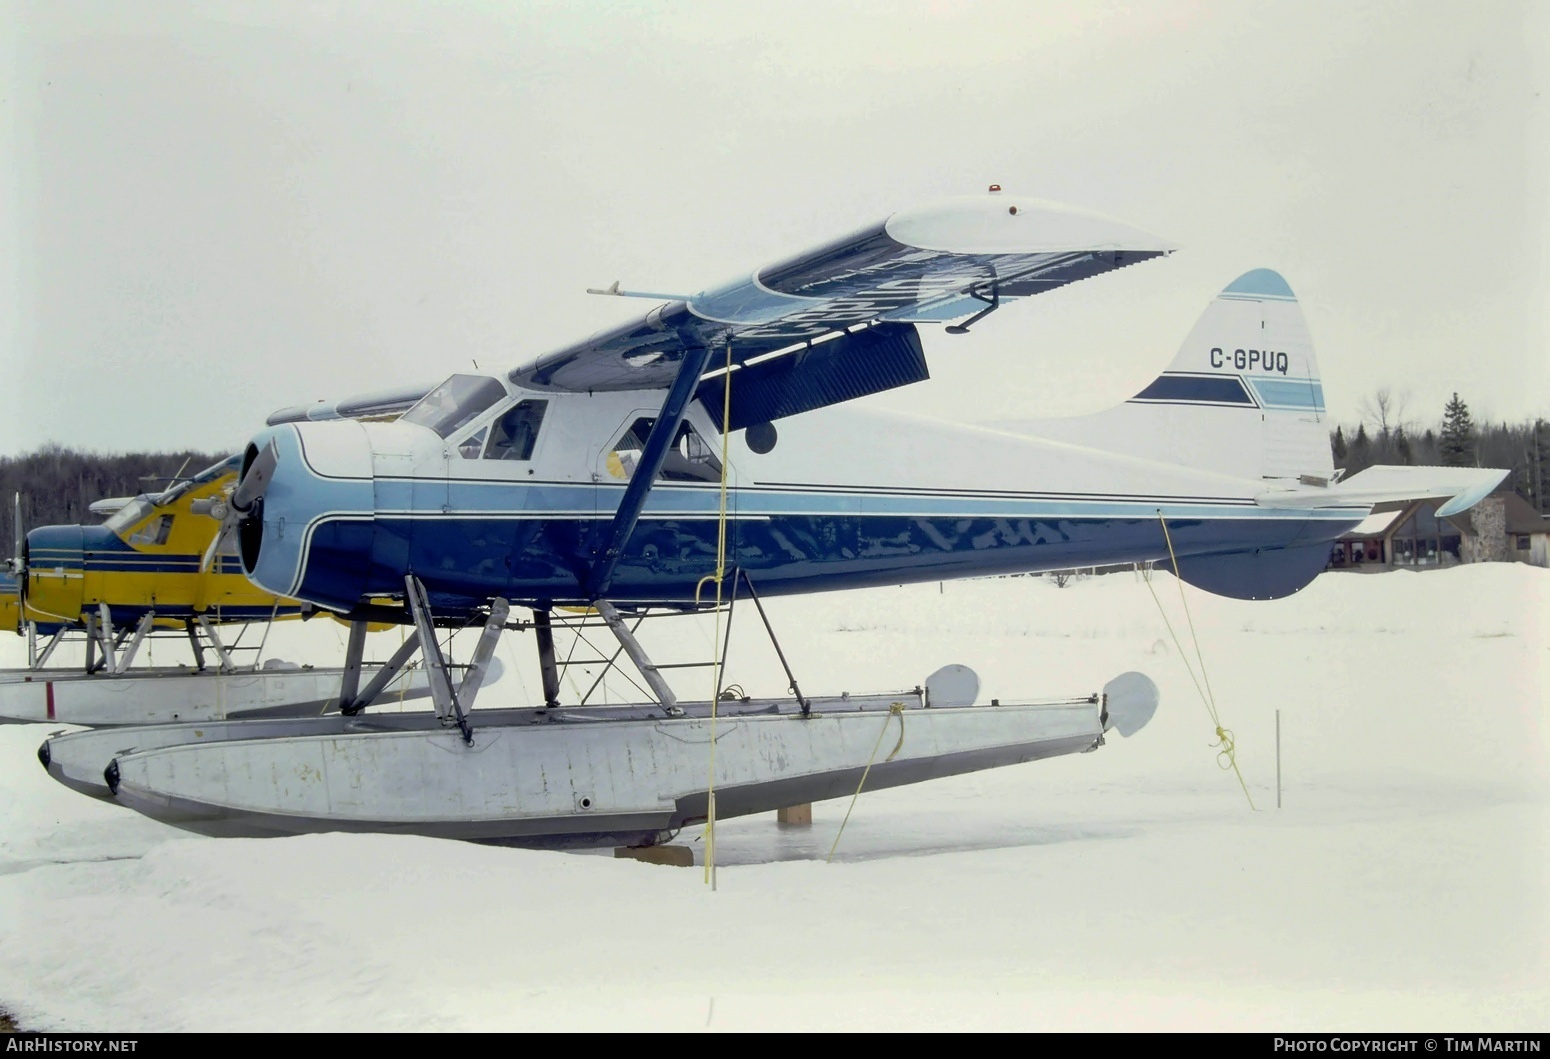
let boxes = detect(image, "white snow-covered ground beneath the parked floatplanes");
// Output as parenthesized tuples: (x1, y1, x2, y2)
(0, 564, 1550, 1031)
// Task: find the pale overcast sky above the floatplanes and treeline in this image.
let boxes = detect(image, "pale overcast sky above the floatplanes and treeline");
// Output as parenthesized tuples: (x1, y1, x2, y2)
(0, 0, 1550, 453)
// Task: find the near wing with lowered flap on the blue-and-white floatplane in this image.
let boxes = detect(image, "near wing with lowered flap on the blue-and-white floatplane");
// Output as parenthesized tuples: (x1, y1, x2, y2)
(510, 194, 1175, 422)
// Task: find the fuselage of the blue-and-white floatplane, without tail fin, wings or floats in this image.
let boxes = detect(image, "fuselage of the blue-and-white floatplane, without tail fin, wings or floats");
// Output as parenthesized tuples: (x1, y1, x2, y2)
(243, 377, 1361, 617)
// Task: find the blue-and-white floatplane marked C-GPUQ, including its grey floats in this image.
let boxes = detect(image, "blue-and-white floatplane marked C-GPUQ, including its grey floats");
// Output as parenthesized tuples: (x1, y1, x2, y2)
(45, 194, 1502, 845)
